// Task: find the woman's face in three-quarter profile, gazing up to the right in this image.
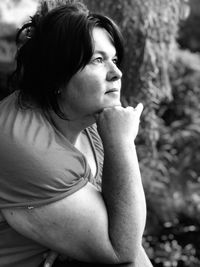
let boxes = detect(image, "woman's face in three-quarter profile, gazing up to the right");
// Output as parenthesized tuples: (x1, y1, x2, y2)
(60, 27, 122, 119)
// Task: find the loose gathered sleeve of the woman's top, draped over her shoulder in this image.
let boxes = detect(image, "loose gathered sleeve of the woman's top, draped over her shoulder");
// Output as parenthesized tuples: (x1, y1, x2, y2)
(0, 95, 90, 208)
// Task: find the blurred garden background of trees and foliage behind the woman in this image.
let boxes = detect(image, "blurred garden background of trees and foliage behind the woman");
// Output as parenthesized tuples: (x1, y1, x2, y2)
(0, 0, 200, 267)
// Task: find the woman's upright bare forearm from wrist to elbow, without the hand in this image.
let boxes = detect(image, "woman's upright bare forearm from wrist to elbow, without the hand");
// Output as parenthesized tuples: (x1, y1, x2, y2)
(102, 143, 146, 262)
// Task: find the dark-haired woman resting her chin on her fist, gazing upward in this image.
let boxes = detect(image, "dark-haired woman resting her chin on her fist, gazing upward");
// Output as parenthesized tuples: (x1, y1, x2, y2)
(0, 2, 151, 267)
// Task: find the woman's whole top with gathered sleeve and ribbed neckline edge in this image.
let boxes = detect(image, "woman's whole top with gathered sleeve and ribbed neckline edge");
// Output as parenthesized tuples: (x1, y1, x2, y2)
(0, 92, 103, 267)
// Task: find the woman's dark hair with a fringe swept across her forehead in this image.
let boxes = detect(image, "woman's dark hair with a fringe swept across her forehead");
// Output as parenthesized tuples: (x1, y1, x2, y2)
(11, 2, 123, 117)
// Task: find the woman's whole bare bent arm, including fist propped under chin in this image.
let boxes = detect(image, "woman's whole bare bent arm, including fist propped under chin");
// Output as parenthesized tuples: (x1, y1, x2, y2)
(3, 107, 146, 264)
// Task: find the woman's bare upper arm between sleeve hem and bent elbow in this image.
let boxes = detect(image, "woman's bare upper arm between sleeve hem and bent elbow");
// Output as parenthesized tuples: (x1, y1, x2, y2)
(2, 183, 118, 263)
